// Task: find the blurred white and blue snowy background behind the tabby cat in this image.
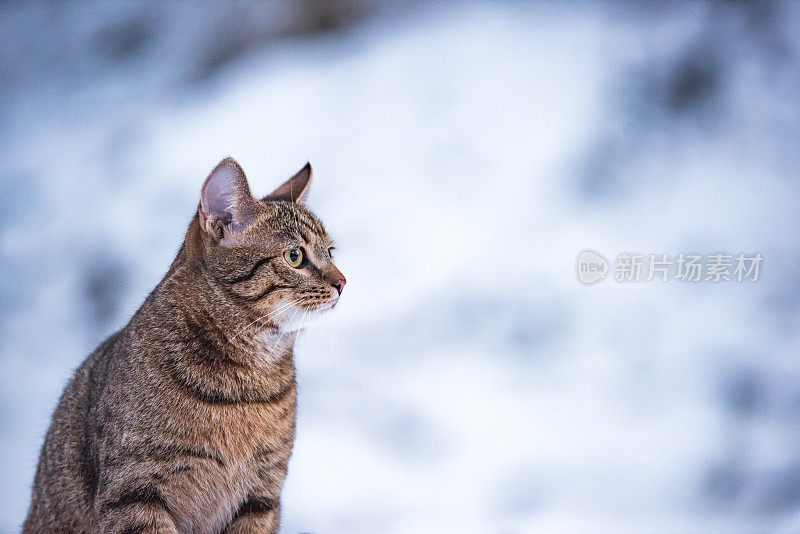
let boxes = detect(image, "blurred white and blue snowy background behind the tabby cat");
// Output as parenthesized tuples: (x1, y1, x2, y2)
(0, 1, 800, 534)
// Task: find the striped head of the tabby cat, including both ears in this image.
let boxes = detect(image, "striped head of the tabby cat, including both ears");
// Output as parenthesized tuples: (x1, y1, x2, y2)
(196, 158, 345, 331)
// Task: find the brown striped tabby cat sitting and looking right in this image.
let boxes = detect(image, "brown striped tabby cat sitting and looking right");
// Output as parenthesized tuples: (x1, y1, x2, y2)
(23, 158, 345, 534)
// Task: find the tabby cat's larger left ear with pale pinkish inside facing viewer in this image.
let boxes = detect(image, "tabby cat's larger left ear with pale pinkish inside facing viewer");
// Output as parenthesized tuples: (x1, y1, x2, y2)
(199, 158, 258, 239)
